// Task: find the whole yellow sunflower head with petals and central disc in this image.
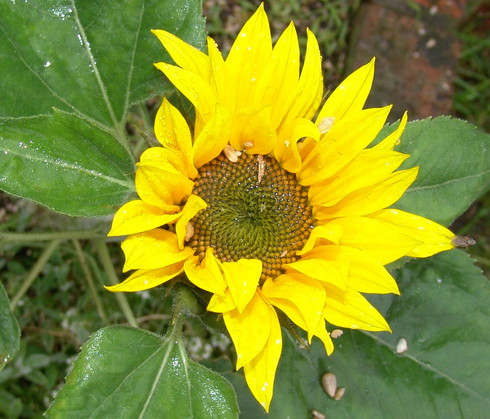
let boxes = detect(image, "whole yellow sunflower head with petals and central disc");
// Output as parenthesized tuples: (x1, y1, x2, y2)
(107, 5, 454, 411)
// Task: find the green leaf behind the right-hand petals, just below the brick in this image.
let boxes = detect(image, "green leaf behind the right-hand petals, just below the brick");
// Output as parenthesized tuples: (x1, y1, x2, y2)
(394, 116, 490, 225)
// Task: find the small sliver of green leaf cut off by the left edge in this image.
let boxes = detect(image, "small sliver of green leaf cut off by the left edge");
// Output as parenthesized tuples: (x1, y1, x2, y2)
(0, 282, 20, 371)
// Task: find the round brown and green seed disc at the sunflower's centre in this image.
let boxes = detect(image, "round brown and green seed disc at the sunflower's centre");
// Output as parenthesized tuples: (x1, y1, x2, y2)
(189, 153, 313, 279)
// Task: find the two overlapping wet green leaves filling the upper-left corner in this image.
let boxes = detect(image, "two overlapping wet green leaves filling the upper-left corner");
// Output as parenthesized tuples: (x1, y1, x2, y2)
(0, 0, 204, 216)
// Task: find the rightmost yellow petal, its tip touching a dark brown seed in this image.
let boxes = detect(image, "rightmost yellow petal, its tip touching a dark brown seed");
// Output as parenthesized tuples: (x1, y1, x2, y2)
(369, 209, 454, 258)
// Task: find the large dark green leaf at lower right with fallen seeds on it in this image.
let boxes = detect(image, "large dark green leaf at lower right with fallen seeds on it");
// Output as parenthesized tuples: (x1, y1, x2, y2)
(233, 250, 490, 419)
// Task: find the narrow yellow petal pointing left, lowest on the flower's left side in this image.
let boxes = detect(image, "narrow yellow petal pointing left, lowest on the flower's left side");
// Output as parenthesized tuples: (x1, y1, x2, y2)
(104, 262, 184, 292)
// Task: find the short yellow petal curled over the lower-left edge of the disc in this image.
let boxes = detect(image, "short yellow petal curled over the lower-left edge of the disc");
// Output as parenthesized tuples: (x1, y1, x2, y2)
(184, 251, 228, 296)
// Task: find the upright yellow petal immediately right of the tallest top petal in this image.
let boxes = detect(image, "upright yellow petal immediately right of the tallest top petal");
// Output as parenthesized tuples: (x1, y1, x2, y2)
(255, 22, 299, 129)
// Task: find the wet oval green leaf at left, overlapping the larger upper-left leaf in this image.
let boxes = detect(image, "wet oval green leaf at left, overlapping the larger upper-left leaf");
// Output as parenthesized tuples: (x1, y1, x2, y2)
(0, 111, 134, 216)
